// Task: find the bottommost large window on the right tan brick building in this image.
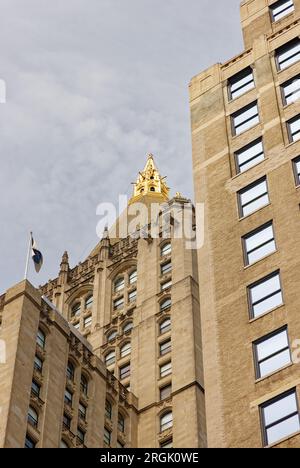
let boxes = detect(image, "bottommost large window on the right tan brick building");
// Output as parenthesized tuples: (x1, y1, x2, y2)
(260, 389, 300, 446)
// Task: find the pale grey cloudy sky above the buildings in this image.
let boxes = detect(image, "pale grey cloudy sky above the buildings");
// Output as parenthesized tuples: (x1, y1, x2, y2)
(0, 0, 243, 291)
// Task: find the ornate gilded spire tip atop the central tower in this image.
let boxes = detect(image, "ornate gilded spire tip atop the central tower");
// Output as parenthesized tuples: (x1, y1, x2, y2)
(129, 154, 170, 204)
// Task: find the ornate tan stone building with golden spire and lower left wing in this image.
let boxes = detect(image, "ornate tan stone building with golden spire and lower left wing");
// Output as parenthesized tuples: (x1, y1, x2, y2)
(0, 156, 206, 448)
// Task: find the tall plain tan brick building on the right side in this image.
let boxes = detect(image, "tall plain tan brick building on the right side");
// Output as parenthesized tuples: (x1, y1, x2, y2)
(190, 0, 300, 447)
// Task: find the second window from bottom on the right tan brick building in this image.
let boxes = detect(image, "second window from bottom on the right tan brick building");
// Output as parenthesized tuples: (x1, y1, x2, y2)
(254, 327, 291, 379)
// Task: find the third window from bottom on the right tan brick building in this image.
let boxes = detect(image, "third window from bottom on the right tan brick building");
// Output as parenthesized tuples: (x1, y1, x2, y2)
(248, 271, 283, 318)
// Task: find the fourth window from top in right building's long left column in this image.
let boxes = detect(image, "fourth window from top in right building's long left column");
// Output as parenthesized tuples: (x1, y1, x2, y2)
(238, 177, 270, 217)
